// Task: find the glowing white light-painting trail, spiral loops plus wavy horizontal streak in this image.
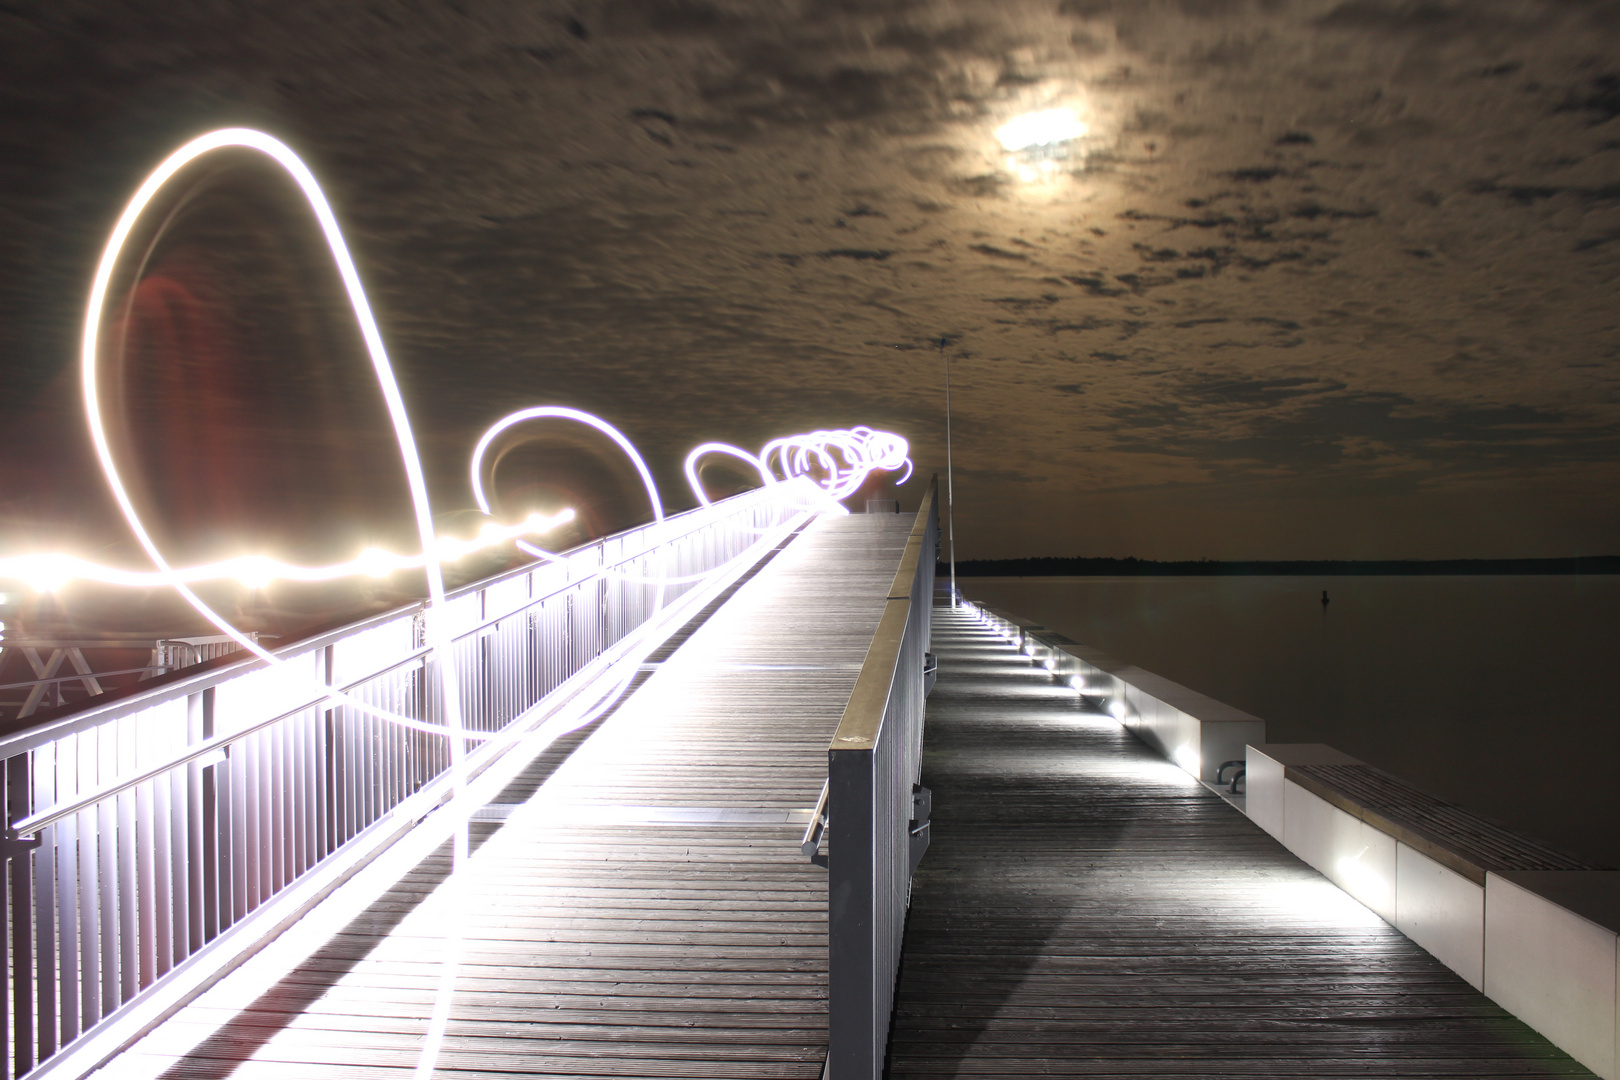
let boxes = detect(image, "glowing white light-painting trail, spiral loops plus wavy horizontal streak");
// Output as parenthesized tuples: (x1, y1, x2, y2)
(0, 128, 912, 1077)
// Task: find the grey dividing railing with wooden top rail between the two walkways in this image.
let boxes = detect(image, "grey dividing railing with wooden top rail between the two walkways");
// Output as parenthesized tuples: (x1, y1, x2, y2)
(822, 479, 940, 1080)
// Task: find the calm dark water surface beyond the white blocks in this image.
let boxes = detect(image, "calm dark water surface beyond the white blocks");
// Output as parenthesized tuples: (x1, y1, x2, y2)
(959, 576, 1620, 866)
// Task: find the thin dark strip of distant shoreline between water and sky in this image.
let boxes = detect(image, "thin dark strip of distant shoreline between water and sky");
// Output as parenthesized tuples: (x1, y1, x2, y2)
(940, 555, 1620, 578)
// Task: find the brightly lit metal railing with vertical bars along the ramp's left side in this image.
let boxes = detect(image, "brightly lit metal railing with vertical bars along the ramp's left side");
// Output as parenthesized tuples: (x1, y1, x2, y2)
(0, 484, 804, 1078)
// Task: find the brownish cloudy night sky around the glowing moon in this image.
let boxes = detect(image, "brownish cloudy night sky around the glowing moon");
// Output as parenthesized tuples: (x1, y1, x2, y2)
(0, 0, 1620, 559)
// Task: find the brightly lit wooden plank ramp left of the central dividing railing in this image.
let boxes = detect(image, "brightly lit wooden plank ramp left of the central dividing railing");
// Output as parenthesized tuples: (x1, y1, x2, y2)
(109, 515, 910, 1080)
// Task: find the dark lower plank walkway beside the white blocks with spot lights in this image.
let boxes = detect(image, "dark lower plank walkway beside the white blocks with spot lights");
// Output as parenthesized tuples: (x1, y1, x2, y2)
(889, 609, 1591, 1078)
